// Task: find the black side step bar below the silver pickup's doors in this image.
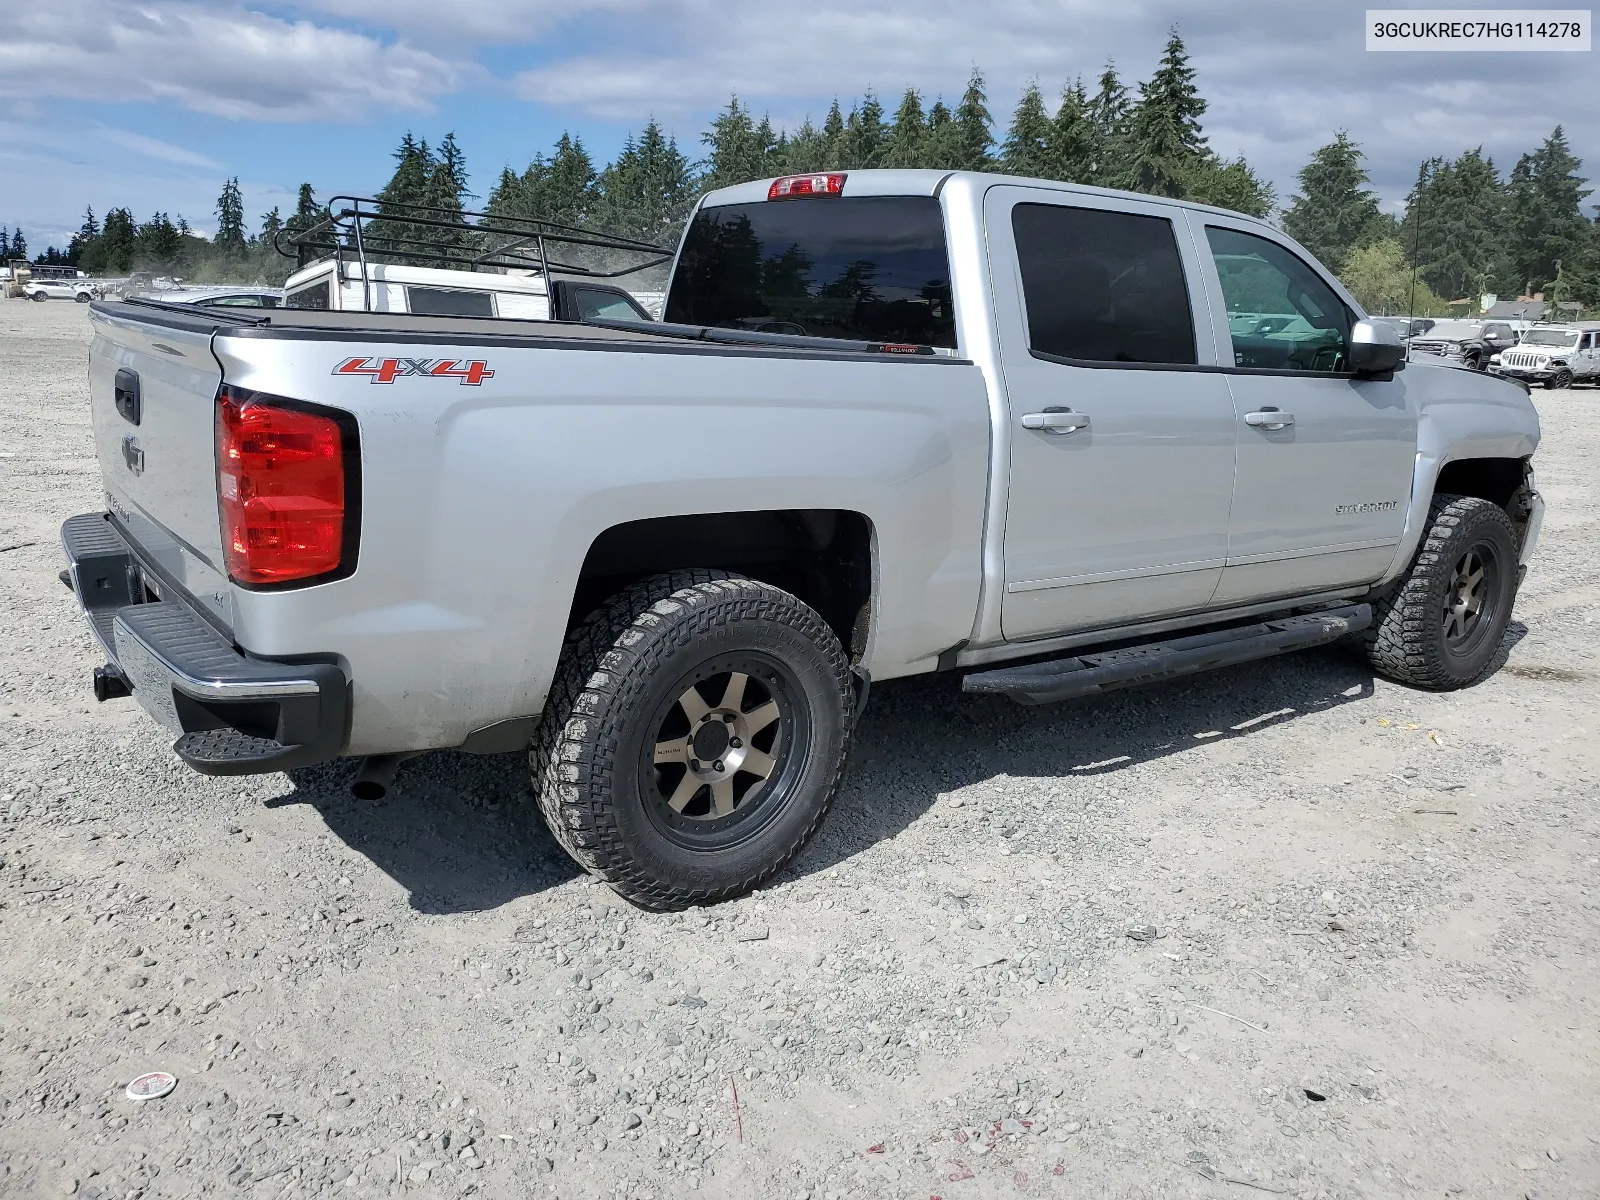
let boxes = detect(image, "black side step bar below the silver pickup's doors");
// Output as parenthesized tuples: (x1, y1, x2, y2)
(962, 605, 1373, 704)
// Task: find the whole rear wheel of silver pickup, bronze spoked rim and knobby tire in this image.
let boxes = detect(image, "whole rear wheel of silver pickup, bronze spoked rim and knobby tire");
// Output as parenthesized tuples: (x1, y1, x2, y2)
(530, 570, 853, 909)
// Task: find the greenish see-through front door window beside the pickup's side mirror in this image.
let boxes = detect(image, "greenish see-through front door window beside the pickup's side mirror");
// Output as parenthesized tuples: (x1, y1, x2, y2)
(1205, 226, 1350, 371)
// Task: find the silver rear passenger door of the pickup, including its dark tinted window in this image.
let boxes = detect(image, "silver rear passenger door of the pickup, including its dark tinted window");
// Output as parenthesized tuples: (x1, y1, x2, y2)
(986, 186, 1235, 642)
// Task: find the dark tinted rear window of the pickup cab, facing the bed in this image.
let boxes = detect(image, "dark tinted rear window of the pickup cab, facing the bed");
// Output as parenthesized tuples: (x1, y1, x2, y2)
(662, 195, 955, 347)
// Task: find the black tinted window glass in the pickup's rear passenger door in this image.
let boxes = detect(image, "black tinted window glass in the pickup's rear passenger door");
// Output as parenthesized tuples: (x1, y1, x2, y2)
(1011, 205, 1195, 365)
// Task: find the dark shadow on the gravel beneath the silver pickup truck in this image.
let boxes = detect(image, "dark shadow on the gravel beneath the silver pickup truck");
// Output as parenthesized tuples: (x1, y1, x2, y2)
(269, 622, 1526, 914)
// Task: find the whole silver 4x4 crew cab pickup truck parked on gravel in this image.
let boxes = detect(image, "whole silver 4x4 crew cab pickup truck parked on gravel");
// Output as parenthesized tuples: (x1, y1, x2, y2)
(62, 171, 1542, 907)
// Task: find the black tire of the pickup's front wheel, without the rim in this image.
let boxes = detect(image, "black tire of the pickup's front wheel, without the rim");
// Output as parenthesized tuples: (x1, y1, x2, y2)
(1365, 496, 1518, 691)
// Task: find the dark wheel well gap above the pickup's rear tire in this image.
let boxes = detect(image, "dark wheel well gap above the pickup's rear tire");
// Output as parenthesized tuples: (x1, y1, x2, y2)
(566, 509, 877, 662)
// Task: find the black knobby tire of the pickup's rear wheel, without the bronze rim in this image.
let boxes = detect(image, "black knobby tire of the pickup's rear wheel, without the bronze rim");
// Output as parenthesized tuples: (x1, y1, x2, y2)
(528, 570, 854, 910)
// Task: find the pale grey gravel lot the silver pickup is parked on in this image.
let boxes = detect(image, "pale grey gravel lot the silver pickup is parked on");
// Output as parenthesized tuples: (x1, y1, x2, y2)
(0, 301, 1600, 1200)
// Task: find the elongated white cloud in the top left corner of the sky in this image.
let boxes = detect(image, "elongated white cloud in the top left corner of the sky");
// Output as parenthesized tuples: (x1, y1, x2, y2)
(0, 0, 472, 122)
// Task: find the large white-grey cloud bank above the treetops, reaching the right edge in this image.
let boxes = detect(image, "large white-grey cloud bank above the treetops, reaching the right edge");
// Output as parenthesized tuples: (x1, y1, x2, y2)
(496, 0, 1600, 200)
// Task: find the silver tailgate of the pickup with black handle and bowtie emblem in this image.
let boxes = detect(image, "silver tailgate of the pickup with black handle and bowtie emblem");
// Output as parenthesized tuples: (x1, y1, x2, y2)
(90, 304, 226, 618)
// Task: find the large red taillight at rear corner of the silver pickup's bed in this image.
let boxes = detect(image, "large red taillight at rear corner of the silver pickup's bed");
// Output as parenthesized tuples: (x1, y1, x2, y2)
(216, 387, 347, 584)
